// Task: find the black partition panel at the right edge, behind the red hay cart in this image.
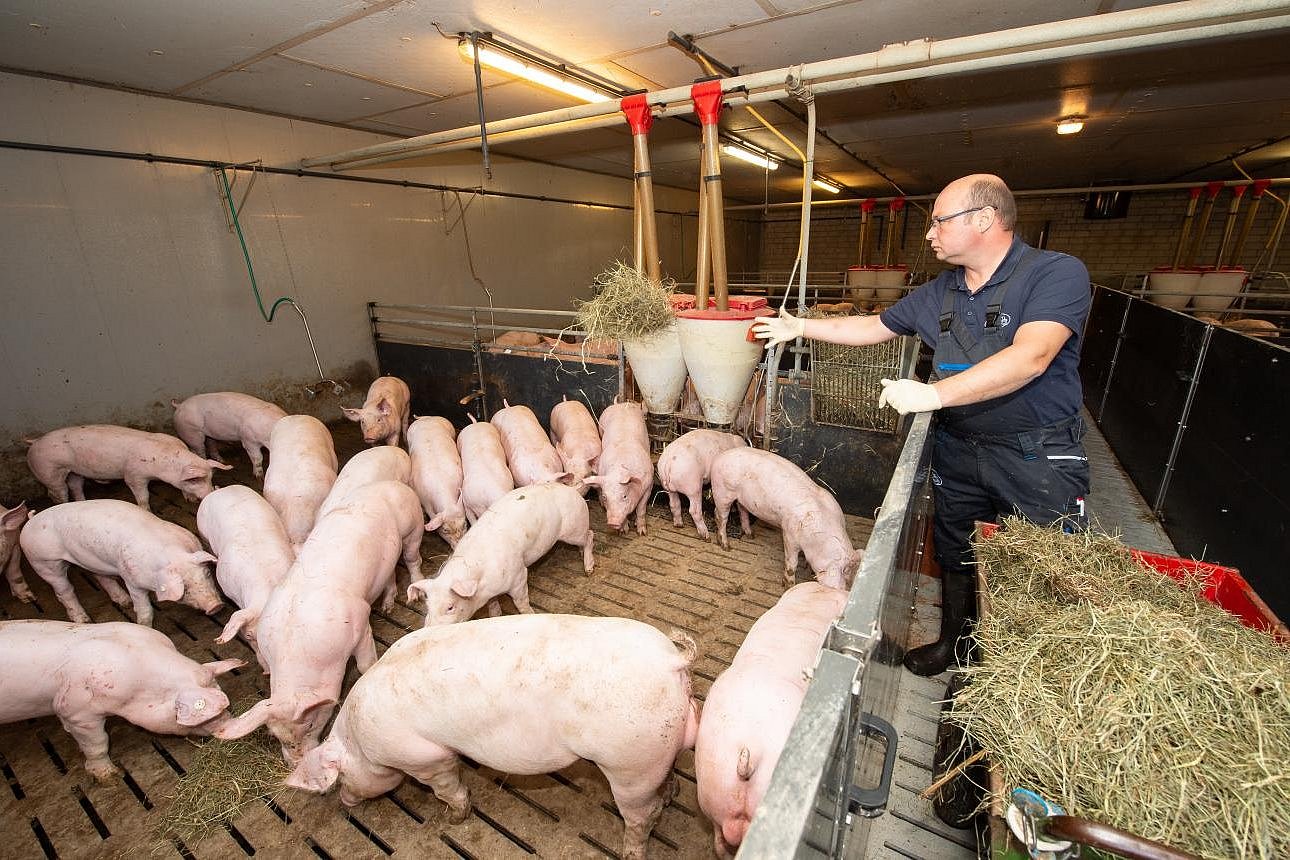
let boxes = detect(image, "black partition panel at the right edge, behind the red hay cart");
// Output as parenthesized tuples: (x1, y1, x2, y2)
(1164, 324, 1290, 619)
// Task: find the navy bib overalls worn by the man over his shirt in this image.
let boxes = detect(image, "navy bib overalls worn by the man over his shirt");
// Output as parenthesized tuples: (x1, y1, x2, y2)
(931, 248, 1089, 585)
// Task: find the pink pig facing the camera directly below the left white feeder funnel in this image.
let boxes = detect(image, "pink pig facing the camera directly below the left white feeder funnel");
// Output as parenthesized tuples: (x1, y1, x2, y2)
(584, 402, 654, 535)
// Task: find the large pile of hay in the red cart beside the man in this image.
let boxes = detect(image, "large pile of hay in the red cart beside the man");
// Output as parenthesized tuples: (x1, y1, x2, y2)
(951, 521, 1290, 860)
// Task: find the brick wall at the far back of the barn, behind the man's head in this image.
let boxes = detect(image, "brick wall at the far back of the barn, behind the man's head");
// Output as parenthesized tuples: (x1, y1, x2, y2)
(760, 190, 1290, 285)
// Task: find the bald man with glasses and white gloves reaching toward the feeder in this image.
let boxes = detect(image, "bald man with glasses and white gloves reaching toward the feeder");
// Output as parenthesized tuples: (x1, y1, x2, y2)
(753, 174, 1090, 676)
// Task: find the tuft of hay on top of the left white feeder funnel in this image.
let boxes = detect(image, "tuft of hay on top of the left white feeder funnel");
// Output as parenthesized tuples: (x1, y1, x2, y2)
(577, 262, 676, 340)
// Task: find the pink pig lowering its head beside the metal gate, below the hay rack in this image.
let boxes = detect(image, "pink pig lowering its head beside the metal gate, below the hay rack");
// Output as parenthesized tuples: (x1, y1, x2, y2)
(712, 447, 863, 589)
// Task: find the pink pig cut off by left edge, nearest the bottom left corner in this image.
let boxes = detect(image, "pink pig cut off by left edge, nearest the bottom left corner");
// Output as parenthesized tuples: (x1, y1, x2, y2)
(0, 621, 243, 781)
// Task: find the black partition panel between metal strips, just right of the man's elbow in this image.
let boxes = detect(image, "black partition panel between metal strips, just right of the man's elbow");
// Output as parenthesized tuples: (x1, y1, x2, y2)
(1094, 300, 1205, 504)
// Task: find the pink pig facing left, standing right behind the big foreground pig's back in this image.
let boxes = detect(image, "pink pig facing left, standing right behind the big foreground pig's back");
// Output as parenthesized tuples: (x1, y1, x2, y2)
(408, 484, 596, 627)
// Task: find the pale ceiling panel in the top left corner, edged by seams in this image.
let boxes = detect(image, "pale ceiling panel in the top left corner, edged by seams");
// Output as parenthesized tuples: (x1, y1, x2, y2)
(0, 0, 372, 93)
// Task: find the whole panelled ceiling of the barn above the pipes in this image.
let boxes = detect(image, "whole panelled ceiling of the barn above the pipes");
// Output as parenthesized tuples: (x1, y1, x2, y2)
(0, 0, 1290, 202)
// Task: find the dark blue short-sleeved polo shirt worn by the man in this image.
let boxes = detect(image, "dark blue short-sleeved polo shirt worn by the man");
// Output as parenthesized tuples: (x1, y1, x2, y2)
(880, 237, 1091, 432)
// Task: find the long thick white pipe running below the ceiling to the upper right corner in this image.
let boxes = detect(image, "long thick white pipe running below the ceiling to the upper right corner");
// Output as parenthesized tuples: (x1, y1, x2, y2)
(301, 0, 1290, 168)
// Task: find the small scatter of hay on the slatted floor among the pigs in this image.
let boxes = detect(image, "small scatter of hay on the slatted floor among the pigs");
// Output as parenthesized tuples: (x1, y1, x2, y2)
(156, 716, 288, 850)
